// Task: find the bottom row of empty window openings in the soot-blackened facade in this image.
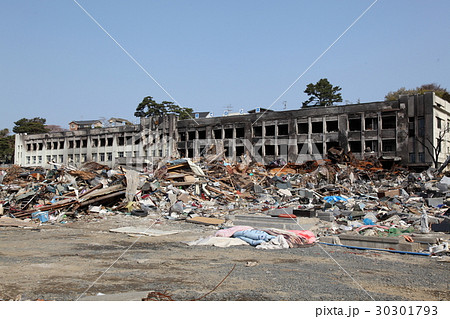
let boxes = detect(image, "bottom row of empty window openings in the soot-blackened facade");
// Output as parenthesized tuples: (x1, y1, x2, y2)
(178, 140, 396, 158)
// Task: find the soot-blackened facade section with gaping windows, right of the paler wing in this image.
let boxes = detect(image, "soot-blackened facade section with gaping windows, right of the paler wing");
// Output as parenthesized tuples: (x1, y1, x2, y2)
(178, 101, 408, 162)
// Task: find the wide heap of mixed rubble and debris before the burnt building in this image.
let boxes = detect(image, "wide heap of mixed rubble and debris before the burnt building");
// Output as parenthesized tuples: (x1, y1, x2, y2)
(0, 148, 450, 253)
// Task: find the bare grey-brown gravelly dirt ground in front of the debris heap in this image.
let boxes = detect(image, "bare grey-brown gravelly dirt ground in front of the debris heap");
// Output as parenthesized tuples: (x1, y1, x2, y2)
(0, 215, 450, 301)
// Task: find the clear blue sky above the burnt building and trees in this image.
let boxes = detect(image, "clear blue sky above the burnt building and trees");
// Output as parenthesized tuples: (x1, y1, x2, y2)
(0, 0, 450, 129)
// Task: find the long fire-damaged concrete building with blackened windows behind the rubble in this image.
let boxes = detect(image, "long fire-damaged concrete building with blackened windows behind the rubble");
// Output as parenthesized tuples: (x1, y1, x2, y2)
(15, 92, 450, 168)
